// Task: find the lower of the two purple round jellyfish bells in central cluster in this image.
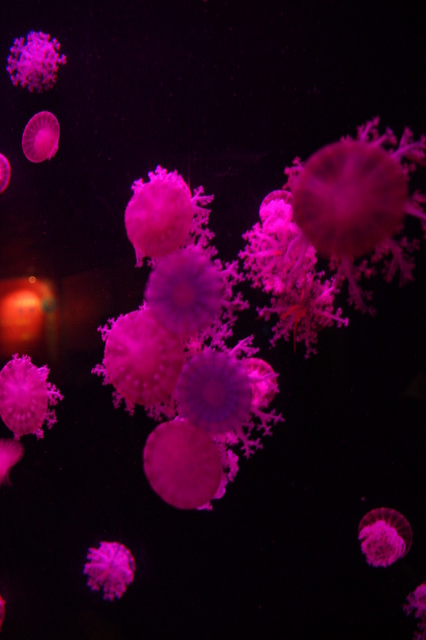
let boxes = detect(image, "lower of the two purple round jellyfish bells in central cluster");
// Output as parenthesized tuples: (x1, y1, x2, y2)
(175, 349, 252, 435)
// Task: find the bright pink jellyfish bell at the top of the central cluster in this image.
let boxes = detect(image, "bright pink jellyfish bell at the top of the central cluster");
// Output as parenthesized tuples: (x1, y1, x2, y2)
(124, 167, 194, 266)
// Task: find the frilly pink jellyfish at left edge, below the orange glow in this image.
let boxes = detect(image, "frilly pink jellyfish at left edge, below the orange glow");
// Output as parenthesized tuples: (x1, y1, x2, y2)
(0, 354, 63, 440)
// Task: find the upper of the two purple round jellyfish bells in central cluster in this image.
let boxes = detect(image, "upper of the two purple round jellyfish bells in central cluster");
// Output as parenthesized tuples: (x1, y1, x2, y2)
(145, 248, 224, 336)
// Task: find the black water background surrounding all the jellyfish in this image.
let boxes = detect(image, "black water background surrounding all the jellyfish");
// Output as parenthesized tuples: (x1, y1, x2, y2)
(0, 0, 426, 640)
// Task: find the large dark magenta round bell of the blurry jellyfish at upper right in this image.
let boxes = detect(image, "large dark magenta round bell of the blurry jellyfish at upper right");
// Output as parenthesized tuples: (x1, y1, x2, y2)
(293, 140, 408, 258)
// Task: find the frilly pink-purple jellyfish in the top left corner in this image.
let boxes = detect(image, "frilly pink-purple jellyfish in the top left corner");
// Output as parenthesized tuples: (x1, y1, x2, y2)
(6, 31, 67, 93)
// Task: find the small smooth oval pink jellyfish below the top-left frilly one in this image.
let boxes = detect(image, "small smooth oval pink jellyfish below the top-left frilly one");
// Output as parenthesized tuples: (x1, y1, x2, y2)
(22, 111, 59, 162)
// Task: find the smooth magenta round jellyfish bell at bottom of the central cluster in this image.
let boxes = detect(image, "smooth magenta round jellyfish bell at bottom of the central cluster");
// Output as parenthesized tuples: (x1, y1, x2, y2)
(143, 419, 222, 509)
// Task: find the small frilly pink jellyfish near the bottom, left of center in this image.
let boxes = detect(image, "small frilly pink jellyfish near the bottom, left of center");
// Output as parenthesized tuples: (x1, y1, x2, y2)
(83, 542, 135, 600)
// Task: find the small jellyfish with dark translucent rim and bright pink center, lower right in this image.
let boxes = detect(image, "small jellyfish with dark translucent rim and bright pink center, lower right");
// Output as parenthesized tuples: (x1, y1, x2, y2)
(358, 507, 413, 567)
